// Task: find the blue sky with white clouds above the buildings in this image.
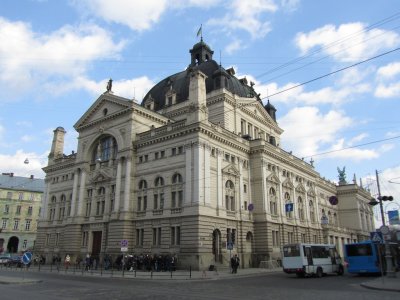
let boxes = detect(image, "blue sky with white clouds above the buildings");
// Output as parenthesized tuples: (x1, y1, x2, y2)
(0, 0, 400, 225)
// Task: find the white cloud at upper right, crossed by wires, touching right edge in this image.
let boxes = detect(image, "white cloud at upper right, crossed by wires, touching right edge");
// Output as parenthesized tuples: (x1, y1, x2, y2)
(295, 23, 400, 62)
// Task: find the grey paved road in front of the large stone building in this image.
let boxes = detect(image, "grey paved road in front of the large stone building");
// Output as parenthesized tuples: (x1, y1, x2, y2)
(0, 270, 399, 300)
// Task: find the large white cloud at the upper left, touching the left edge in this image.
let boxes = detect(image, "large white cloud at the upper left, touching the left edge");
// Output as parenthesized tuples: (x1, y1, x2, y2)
(0, 18, 124, 101)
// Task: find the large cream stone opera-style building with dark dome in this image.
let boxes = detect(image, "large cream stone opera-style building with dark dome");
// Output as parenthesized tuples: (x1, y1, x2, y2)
(37, 40, 374, 269)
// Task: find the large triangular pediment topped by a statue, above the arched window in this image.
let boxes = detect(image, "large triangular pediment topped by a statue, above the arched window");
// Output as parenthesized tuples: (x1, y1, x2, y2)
(74, 93, 133, 130)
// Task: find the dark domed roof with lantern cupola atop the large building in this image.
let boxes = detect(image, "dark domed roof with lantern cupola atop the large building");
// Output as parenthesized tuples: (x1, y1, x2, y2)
(142, 40, 259, 111)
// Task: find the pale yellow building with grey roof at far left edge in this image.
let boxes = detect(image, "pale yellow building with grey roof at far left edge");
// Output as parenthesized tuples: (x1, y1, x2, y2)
(0, 173, 44, 253)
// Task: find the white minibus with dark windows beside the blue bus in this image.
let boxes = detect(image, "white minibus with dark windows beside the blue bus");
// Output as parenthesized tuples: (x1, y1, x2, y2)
(282, 243, 344, 277)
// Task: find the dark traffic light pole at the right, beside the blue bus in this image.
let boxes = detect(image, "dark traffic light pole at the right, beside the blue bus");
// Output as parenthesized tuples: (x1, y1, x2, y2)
(369, 170, 396, 278)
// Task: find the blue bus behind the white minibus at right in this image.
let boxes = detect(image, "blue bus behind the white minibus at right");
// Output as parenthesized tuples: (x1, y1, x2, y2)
(344, 241, 386, 275)
